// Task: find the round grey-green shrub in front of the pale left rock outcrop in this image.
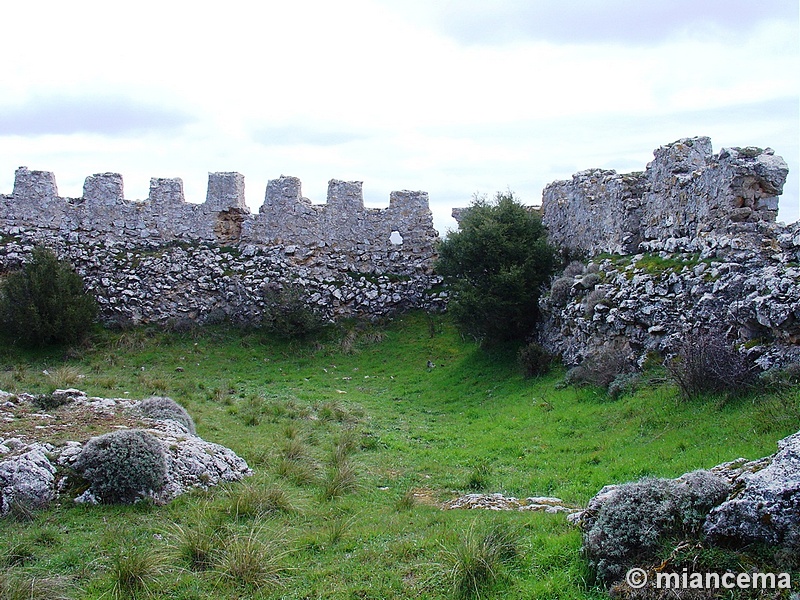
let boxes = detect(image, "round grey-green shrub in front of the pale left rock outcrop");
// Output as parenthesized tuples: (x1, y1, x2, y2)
(74, 429, 167, 504)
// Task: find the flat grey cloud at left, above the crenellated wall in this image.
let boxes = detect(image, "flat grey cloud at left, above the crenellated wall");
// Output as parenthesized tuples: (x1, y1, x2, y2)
(0, 96, 194, 136)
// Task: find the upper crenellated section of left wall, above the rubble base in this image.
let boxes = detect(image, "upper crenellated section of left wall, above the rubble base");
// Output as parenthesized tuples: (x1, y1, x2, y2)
(0, 167, 438, 263)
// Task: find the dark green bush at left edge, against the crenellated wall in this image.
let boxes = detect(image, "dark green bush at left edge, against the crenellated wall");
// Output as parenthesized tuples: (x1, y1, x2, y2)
(0, 247, 97, 346)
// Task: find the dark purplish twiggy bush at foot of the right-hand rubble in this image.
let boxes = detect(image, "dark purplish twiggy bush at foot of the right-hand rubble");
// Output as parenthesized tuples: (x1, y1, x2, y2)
(666, 332, 758, 399)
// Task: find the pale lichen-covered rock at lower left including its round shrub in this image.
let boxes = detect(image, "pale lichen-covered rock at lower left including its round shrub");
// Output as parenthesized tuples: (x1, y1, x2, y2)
(0, 390, 252, 515)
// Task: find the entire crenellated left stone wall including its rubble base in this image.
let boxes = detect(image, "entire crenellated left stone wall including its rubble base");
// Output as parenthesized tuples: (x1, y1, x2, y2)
(0, 167, 444, 323)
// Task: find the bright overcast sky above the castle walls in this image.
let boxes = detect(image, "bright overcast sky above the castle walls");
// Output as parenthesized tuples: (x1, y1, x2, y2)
(0, 0, 800, 233)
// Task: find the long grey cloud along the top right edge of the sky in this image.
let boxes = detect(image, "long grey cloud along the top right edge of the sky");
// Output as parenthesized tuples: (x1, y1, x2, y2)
(428, 0, 798, 45)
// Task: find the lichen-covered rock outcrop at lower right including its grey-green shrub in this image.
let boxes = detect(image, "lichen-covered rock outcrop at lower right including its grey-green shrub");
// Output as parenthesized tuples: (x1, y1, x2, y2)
(568, 432, 800, 583)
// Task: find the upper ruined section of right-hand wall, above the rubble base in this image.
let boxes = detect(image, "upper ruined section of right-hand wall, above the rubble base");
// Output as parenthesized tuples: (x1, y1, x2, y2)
(542, 137, 789, 255)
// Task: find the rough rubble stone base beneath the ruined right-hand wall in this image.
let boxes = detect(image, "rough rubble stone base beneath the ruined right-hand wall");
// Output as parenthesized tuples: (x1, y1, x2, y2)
(539, 247, 800, 369)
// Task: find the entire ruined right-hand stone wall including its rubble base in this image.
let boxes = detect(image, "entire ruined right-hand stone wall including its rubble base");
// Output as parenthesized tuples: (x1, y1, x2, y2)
(538, 137, 800, 368)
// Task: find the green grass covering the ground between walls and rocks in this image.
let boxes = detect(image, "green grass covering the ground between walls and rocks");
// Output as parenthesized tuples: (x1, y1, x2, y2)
(0, 313, 800, 600)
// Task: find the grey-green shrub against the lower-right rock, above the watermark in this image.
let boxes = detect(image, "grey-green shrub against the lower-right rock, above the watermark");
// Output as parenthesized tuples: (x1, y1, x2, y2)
(582, 471, 729, 583)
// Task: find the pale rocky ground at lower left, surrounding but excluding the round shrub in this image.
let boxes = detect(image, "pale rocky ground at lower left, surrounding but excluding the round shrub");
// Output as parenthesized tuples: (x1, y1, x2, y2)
(0, 389, 252, 515)
